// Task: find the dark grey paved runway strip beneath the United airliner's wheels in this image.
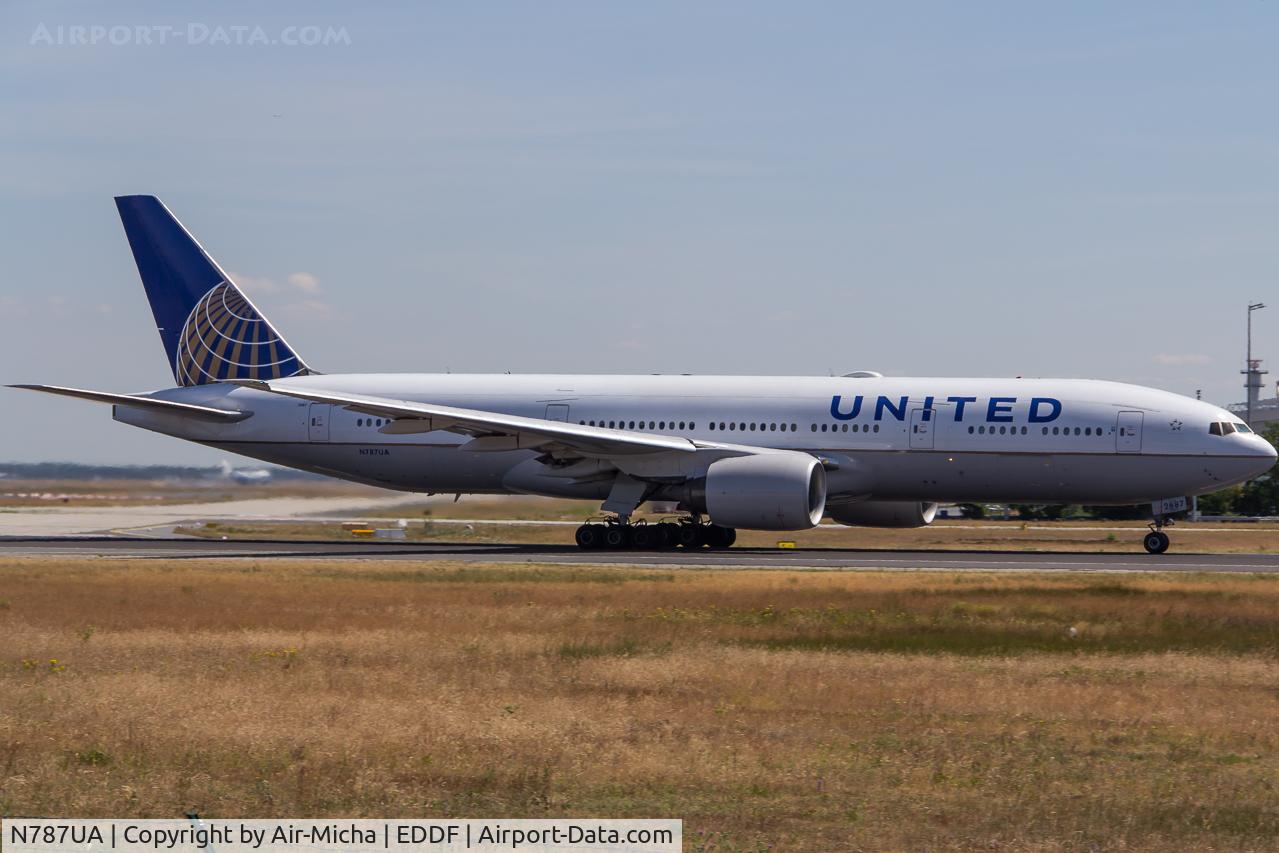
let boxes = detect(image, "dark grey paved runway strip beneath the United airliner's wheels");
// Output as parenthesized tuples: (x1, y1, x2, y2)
(0, 537, 1279, 573)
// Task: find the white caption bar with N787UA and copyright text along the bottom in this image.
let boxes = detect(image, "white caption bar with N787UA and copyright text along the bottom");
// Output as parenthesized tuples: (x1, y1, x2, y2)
(0, 817, 683, 853)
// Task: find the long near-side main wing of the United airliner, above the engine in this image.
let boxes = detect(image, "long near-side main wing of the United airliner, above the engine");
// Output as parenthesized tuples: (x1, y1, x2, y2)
(238, 380, 700, 457)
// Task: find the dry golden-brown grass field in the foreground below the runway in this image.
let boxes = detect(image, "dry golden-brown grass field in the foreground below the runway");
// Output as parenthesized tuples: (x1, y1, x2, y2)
(0, 559, 1279, 852)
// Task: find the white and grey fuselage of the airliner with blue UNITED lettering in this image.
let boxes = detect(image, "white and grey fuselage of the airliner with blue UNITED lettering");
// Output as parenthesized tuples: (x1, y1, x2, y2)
(115, 373, 1275, 504)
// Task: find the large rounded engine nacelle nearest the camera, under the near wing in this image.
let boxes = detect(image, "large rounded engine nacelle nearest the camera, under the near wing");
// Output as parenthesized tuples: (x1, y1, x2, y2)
(703, 451, 826, 531)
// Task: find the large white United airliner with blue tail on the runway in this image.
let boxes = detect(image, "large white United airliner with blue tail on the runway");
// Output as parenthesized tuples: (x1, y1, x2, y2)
(14, 196, 1275, 554)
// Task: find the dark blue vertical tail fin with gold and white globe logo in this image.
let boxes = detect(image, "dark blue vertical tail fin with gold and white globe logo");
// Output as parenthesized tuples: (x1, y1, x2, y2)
(115, 196, 312, 385)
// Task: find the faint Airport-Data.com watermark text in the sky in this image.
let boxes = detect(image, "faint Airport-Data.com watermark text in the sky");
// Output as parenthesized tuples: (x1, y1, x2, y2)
(28, 20, 350, 47)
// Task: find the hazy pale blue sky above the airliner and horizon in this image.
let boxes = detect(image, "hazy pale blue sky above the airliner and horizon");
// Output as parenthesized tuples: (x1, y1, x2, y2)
(0, 0, 1279, 464)
